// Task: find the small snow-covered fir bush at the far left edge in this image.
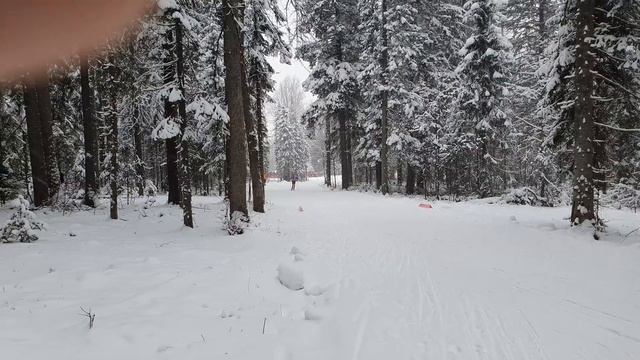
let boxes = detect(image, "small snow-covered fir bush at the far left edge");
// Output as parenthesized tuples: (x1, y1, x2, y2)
(0, 195, 44, 243)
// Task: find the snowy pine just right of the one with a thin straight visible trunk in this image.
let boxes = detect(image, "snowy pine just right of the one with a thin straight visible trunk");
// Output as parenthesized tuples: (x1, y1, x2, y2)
(401, 0, 470, 196)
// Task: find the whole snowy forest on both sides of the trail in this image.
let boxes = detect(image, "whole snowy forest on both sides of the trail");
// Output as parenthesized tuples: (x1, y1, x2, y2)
(0, 0, 640, 233)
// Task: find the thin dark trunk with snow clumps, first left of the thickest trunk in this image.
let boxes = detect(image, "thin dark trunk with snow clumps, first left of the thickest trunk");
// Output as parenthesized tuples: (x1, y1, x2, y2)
(175, 19, 193, 228)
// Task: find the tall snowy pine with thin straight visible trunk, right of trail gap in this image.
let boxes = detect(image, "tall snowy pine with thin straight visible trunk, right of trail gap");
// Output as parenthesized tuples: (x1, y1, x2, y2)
(359, 0, 430, 194)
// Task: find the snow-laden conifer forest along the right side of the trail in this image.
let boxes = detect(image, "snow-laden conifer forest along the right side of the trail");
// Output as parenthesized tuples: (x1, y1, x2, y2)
(298, 0, 640, 228)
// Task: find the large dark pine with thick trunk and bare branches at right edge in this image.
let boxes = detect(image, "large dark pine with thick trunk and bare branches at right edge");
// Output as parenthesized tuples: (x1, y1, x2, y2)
(542, 0, 640, 223)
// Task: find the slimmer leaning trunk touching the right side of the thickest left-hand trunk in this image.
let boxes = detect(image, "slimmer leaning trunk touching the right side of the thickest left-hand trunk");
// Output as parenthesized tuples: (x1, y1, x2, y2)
(241, 59, 265, 213)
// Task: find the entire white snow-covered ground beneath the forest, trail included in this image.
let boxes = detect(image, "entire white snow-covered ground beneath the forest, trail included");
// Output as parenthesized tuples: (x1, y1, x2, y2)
(0, 181, 640, 360)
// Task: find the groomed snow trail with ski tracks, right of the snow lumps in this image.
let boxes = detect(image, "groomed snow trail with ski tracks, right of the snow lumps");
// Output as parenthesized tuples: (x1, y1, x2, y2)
(271, 183, 640, 360)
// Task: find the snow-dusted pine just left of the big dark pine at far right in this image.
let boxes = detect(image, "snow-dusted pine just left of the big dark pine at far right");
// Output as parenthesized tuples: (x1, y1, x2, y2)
(504, 0, 561, 201)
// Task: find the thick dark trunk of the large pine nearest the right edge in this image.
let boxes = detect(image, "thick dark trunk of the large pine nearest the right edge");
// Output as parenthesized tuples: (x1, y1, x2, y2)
(571, 0, 595, 224)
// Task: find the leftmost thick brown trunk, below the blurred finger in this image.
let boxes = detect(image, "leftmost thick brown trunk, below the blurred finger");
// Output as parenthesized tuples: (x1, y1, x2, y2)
(23, 78, 49, 207)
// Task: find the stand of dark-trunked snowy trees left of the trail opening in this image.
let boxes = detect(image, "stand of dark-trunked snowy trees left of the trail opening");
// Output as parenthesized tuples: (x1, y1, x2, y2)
(0, 0, 291, 232)
